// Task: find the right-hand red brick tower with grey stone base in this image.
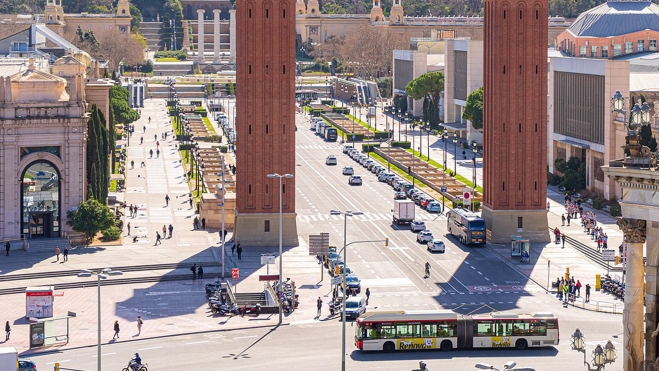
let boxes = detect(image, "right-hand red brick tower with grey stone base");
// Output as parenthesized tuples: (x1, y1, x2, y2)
(483, 0, 549, 243)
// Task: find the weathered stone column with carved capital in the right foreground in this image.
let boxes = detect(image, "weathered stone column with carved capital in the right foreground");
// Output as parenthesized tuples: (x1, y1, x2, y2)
(616, 218, 646, 371)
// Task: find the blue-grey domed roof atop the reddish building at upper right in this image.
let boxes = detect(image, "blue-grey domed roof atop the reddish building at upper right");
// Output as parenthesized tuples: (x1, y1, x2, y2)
(568, 1, 659, 37)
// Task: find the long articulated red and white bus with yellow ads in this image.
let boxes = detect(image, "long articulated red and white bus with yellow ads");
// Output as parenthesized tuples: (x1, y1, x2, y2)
(355, 310, 559, 352)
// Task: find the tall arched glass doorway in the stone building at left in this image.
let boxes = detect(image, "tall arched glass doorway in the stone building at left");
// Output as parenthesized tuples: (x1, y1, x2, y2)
(21, 160, 61, 238)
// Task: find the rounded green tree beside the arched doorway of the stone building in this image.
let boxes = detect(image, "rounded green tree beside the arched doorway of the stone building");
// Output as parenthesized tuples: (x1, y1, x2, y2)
(66, 198, 114, 243)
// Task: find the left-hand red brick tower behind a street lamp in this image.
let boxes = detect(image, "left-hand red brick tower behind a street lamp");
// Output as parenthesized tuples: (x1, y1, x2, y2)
(234, 0, 298, 246)
